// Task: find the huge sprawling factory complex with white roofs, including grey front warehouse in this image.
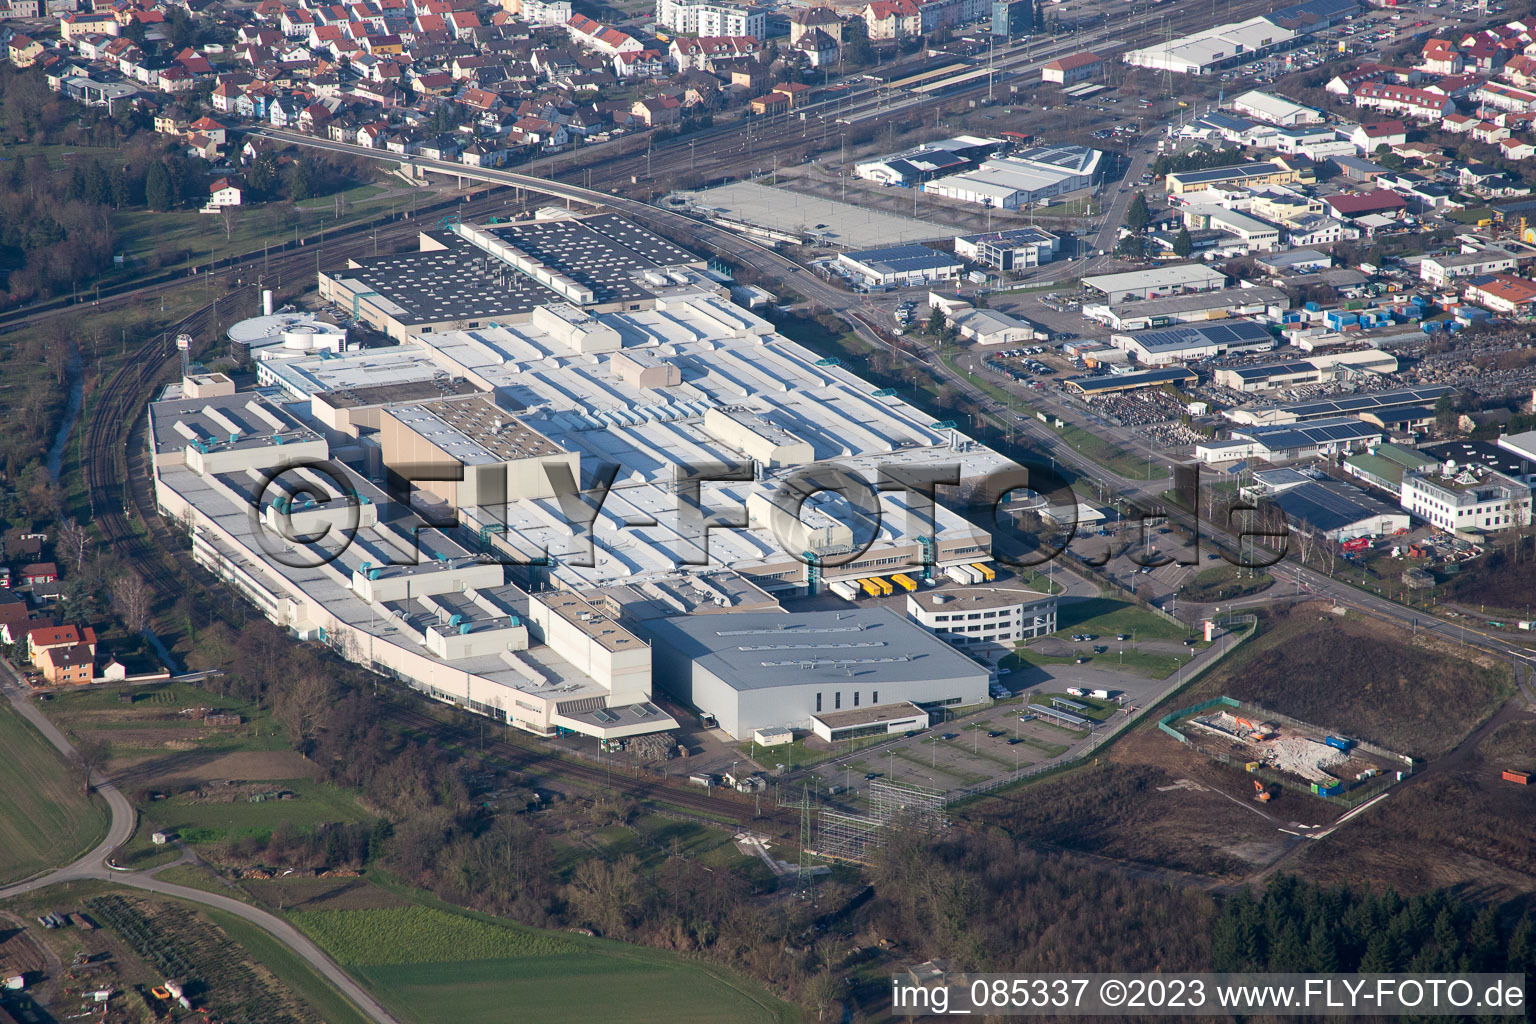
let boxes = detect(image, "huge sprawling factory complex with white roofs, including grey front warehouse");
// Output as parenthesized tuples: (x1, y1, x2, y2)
(151, 213, 1055, 738)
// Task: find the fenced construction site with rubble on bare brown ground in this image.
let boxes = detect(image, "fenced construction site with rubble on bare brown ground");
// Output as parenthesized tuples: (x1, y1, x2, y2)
(1158, 697, 1413, 804)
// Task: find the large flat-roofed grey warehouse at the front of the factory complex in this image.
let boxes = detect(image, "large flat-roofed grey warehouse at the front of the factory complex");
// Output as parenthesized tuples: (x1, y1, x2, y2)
(645, 608, 988, 740)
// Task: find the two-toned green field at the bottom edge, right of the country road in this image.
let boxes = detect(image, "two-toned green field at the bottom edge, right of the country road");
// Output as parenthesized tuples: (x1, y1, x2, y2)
(290, 906, 796, 1024)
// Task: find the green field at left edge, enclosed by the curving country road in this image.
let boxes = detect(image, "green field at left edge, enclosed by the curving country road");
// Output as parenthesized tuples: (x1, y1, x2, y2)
(0, 700, 108, 881)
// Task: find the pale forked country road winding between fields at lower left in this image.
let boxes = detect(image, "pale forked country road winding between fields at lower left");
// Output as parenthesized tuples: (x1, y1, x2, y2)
(0, 663, 399, 1024)
